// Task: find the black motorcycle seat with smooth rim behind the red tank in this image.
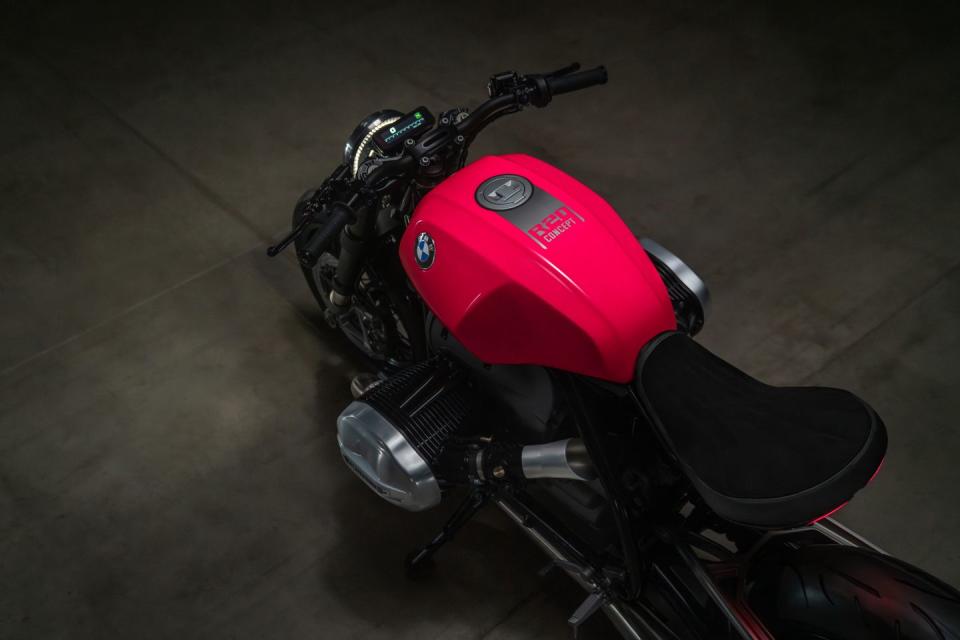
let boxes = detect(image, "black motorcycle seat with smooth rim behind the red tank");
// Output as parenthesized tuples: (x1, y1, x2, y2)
(635, 333, 887, 528)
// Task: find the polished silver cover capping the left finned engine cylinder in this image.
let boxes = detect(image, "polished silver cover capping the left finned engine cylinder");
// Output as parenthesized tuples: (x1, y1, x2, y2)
(337, 401, 440, 511)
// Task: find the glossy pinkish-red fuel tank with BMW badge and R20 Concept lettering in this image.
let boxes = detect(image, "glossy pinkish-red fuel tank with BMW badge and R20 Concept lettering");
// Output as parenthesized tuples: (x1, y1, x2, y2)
(400, 155, 676, 382)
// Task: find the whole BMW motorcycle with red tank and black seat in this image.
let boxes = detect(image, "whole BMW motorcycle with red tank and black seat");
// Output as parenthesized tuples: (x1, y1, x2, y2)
(268, 64, 960, 640)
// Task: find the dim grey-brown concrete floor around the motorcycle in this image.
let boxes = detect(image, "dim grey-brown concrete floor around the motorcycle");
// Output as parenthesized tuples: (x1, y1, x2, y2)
(0, 3, 960, 640)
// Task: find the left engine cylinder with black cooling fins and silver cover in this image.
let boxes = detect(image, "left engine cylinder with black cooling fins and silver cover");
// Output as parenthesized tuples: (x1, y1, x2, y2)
(337, 358, 471, 511)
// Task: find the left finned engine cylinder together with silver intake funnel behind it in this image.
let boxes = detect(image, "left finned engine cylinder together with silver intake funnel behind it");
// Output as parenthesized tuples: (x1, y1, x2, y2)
(337, 357, 595, 511)
